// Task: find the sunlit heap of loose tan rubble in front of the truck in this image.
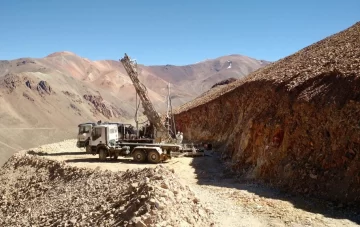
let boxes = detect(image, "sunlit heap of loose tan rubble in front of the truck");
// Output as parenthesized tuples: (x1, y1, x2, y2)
(0, 153, 212, 227)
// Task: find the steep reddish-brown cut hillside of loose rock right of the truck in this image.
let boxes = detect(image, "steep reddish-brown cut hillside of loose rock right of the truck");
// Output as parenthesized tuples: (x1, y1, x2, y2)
(176, 22, 360, 202)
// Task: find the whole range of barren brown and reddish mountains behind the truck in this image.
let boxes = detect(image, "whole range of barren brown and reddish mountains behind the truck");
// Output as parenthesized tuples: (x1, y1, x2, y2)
(0, 52, 267, 165)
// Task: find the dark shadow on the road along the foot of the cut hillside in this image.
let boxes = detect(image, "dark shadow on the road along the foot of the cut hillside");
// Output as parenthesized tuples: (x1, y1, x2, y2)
(191, 153, 360, 224)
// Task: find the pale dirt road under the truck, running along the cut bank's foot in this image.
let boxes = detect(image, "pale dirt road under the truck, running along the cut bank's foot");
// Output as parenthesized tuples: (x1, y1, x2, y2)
(33, 140, 360, 227)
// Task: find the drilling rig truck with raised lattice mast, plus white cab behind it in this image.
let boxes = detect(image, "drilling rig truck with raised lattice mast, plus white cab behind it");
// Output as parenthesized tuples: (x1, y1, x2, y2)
(77, 54, 210, 163)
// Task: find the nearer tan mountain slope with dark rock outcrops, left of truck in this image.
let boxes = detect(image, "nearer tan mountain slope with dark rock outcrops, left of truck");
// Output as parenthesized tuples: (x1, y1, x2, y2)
(0, 72, 129, 164)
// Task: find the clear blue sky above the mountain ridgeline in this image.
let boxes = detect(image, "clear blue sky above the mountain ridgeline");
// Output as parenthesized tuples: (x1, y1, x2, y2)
(0, 0, 360, 65)
